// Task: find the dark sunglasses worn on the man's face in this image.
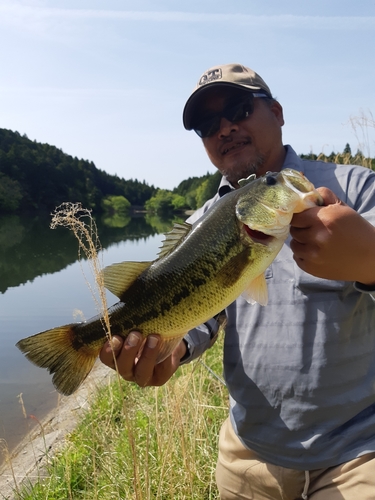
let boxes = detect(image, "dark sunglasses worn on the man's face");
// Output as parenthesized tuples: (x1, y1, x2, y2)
(194, 92, 269, 139)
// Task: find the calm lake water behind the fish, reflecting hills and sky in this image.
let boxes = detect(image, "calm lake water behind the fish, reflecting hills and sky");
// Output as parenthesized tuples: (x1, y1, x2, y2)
(0, 212, 181, 463)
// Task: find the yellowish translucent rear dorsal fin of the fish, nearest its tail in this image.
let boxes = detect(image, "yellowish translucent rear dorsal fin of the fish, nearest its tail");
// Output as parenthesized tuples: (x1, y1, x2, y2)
(102, 262, 152, 299)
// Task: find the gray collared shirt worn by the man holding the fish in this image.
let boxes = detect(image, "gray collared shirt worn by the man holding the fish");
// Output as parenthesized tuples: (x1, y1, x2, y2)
(186, 146, 375, 470)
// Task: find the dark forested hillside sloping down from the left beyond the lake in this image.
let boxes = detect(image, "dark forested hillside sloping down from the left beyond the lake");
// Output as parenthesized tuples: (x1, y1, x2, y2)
(0, 129, 156, 212)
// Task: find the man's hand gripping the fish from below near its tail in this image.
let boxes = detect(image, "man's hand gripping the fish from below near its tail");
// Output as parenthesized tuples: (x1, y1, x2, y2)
(99, 332, 186, 387)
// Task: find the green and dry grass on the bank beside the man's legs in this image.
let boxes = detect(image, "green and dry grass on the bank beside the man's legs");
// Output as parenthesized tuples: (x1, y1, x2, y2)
(15, 332, 228, 500)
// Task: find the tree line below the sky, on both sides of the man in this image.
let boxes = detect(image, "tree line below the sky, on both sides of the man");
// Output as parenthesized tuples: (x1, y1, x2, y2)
(0, 128, 375, 216)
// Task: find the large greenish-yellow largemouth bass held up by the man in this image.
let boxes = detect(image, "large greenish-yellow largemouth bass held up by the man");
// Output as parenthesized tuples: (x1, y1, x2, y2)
(17, 169, 322, 395)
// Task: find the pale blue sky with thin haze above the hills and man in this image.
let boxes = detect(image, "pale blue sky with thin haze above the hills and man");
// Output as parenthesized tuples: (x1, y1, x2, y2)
(0, 0, 375, 189)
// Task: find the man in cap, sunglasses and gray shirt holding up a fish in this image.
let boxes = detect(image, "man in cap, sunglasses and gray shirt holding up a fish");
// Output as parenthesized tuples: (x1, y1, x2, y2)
(101, 64, 375, 500)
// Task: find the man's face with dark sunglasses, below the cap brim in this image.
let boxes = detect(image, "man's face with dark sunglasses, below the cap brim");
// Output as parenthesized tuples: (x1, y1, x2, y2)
(195, 89, 285, 187)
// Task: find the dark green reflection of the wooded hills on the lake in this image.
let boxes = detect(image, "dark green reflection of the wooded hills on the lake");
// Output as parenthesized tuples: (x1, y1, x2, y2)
(0, 215, 185, 293)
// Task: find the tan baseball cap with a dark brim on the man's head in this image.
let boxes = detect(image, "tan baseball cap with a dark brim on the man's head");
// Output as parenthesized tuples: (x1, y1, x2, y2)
(182, 64, 272, 130)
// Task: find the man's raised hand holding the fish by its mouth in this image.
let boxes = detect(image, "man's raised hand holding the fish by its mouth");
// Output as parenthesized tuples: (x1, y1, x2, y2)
(290, 188, 375, 284)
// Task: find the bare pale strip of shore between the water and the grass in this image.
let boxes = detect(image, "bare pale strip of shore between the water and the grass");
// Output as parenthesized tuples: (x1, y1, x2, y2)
(0, 361, 115, 500)
